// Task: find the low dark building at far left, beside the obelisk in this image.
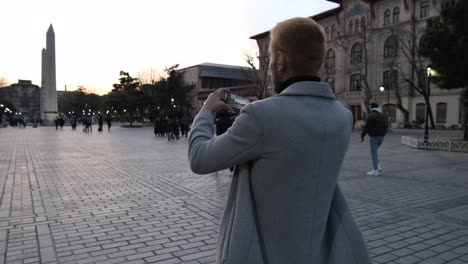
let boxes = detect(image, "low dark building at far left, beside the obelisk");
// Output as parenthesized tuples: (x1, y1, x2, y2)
(0, 80, 41, 122)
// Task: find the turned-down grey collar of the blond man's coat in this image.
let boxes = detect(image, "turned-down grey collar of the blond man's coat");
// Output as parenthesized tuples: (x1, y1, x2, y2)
(278, 81, 336, 99)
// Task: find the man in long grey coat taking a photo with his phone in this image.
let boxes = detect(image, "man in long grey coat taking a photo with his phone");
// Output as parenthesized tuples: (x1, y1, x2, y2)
(188, 18, 371, 264)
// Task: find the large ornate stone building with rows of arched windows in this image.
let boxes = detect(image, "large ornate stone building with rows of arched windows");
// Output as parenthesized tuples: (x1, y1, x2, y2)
(251, 0, 463, 127)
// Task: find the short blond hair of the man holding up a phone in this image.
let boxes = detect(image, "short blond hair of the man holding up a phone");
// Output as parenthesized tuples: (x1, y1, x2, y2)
(270, 17, 325, 74)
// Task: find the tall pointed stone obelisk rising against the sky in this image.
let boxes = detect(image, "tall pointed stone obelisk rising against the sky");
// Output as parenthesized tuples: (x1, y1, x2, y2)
(41, 24, 57, 125)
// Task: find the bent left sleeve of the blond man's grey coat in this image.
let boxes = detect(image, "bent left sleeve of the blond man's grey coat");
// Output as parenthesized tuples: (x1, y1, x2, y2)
(188, 105, 263, 174)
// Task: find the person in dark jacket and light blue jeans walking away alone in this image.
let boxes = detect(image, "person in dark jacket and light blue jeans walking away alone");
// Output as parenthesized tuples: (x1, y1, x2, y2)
(361, 103, 388, 176)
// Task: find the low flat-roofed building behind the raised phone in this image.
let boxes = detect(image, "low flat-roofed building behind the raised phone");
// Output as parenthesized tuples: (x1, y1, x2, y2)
(179, 63, 251, 109)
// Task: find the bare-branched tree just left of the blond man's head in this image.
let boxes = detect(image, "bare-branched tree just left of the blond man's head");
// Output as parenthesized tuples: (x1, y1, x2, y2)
(245, 49, 271, 99)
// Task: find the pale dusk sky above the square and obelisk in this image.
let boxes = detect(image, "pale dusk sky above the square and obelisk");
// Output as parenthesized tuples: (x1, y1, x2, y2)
(0, 0, 337, 94)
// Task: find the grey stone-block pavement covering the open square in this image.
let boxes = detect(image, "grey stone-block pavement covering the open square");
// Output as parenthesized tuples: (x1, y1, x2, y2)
(0, 127, 468, 264)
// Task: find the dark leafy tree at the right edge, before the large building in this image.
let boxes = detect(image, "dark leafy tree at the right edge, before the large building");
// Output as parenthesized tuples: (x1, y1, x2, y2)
(419, 0, 468, 140)
